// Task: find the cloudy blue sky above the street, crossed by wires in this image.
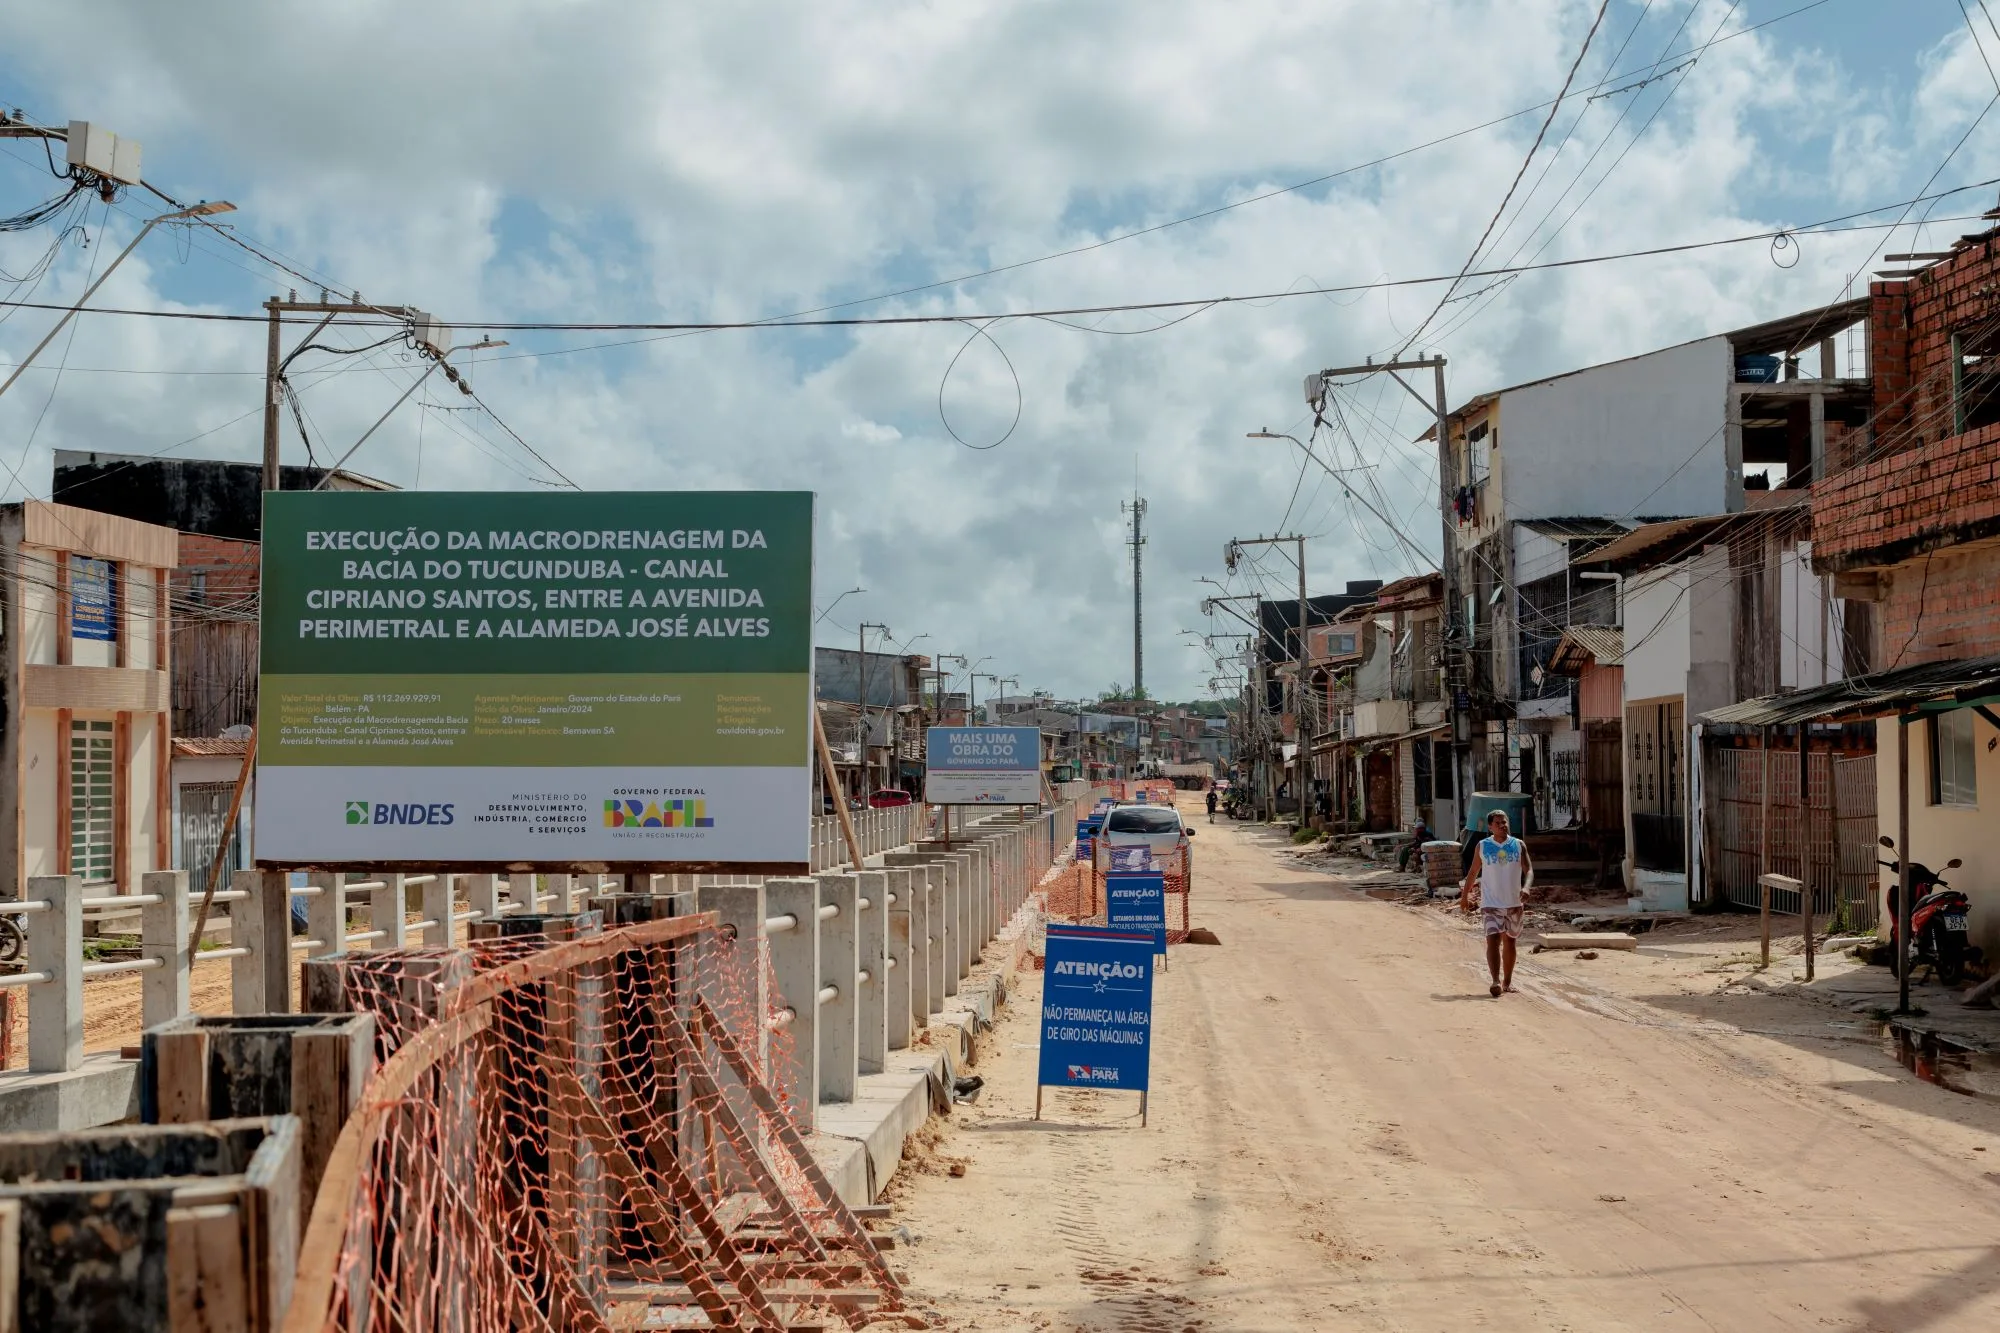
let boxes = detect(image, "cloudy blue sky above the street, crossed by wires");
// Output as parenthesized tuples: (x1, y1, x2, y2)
(0, 0, 2000, 699)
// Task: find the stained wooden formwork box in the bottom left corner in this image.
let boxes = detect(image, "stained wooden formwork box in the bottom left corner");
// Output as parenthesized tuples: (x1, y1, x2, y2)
(0, 1115, 300, 1333)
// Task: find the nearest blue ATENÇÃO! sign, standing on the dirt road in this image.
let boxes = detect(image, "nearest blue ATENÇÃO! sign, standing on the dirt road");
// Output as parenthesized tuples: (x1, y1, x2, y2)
(1038, 925, 1152, 1093)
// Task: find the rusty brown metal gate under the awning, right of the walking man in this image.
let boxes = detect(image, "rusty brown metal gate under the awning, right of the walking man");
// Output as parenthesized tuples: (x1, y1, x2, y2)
(1708, 747, 1876, 931)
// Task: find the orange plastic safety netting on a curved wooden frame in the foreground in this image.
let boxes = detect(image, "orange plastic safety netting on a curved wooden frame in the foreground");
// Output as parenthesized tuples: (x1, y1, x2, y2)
(286, 913, 922, 1333)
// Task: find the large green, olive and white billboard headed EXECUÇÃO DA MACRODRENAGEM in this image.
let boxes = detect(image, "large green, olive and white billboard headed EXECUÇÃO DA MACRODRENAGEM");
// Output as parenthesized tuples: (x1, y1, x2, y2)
(256, 490, 812, 871)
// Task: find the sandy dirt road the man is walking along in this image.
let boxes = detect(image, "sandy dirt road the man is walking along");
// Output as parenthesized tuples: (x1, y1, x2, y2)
(892, 800, 2000, 1333)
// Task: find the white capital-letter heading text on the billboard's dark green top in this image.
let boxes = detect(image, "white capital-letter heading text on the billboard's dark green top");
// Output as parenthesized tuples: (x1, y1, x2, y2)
(296, 526, 772, 640)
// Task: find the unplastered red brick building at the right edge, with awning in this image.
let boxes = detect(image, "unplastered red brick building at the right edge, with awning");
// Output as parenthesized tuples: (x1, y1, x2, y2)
(1730, 228, 2000, 957)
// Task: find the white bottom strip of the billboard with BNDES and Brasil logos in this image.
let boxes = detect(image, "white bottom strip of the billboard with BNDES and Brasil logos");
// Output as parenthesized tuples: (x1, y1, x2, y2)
(256, 767, 812, 865)
